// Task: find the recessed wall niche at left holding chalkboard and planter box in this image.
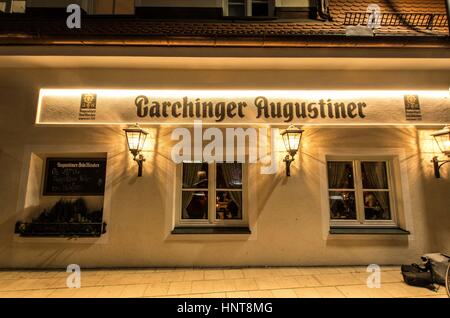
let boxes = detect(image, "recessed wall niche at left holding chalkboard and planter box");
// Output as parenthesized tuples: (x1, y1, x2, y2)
(15, 153, 107, 238)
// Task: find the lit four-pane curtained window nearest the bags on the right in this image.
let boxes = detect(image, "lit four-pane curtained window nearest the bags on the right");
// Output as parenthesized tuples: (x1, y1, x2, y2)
(327, 160, 396, 226)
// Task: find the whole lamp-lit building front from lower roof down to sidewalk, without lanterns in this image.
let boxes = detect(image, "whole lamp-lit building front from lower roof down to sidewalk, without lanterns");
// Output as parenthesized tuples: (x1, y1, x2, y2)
(0, 1, 450, 268)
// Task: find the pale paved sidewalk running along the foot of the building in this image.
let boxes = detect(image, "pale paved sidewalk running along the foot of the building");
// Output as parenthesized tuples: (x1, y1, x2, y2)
(0, 266, 447, 298)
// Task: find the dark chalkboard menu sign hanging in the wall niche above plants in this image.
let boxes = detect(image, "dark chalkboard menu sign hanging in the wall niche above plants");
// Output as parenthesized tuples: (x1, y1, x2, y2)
(43, 158, 106, 196)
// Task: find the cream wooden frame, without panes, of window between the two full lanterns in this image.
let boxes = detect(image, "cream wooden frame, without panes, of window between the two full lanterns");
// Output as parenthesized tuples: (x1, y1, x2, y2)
(175, 161, 249, 228)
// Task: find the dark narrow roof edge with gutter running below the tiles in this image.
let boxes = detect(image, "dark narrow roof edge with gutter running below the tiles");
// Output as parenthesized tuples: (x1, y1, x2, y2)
(0, 34, 450, 49)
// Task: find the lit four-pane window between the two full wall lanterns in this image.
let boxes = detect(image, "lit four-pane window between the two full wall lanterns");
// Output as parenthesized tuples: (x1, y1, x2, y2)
(177, 162, 247, 226)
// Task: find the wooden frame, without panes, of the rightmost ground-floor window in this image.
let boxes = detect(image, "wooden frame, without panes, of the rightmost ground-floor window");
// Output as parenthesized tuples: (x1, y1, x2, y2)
(325, 156, 399, 227)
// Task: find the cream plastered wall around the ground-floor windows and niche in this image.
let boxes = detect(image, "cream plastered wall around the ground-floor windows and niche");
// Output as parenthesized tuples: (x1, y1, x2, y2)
(0, 68, 450, 267)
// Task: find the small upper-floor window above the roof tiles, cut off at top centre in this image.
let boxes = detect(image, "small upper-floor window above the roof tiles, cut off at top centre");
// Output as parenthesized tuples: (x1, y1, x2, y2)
(224, 0, 273, 17)
